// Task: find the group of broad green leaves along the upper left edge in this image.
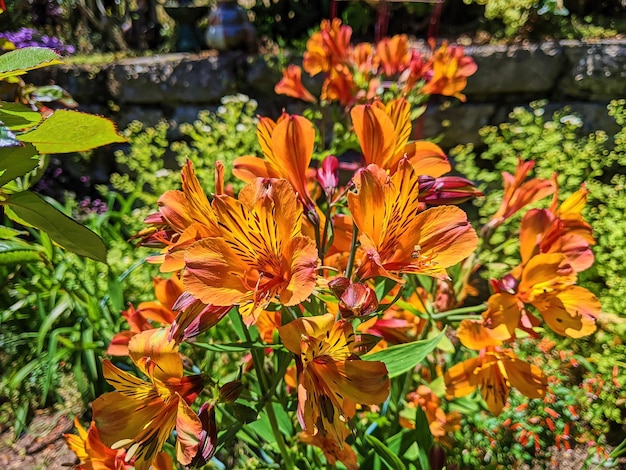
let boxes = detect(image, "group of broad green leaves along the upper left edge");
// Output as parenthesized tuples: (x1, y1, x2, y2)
(0, 47, 124, 261)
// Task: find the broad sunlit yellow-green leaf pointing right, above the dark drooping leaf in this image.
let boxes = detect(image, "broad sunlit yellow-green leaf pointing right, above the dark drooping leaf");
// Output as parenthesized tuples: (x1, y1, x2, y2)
(18, 109, 126, 153)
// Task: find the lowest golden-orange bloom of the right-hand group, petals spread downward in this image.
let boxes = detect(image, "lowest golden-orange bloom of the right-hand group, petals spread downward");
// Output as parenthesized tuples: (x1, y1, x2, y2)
(444, 320, 547, 415)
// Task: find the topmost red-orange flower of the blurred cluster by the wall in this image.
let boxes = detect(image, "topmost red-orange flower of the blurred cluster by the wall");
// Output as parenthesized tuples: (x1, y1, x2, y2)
(302, 18, 352, 76)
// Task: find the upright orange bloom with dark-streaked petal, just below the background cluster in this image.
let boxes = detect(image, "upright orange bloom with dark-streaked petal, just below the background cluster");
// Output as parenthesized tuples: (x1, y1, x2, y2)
(350, 98, 452, 178)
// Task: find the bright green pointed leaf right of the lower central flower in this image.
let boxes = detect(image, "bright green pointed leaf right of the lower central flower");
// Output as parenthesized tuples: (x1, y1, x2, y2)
(361, 330, 445, 378)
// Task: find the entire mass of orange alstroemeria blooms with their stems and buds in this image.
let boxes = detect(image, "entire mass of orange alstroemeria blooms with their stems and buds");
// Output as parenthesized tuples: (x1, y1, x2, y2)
(62, 21, 600, 470)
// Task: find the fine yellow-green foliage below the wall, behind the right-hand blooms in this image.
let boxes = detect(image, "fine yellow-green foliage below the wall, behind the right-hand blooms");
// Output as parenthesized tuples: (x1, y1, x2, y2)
(451, 100, 626, 313)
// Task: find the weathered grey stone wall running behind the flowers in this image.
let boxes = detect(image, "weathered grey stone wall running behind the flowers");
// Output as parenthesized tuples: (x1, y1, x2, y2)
(29, 40, 626, 148)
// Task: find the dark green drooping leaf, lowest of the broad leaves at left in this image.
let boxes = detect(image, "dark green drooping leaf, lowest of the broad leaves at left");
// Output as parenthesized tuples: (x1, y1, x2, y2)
(4, 191, 106, 263)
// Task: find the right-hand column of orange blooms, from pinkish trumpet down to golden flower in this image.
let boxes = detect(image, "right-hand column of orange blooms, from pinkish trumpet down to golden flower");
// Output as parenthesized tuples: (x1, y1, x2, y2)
(445, 161, 601, 414)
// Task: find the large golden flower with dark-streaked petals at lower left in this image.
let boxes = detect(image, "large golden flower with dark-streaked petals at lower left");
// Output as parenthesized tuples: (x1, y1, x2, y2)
(92, 329, 204, 470)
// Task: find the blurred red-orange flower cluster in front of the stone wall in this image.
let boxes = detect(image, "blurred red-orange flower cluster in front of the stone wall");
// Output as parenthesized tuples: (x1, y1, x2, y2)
(275, 18, 477, 108)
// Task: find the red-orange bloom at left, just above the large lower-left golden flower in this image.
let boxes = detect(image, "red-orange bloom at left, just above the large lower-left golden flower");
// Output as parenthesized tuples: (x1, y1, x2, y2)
(107, 274, 184, 356)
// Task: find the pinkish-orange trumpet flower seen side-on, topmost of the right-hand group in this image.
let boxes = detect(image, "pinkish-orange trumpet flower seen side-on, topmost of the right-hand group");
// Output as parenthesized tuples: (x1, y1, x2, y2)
(484, 159, 556, 230)
